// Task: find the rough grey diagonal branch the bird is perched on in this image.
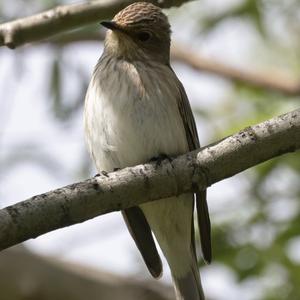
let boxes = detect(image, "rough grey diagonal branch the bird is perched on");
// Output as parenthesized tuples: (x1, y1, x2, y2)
(0, 109, 300, 249)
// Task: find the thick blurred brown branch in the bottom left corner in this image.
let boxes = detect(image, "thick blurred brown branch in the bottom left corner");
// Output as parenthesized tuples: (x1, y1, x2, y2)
(0, 247, 174, 300)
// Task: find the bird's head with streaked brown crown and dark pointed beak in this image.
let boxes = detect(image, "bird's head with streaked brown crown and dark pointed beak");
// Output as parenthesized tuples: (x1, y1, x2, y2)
(101, 2, 171, 63)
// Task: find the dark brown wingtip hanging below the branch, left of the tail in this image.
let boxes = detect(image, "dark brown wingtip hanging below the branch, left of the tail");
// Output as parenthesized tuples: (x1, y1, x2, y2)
(122, 207, 162, 278)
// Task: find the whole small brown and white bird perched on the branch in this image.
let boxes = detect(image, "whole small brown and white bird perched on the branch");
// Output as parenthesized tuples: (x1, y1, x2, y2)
(84, 2, 212, 300)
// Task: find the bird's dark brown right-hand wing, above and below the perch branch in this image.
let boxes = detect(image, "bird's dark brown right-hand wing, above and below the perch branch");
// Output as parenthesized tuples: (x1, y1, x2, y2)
(172, 70, 211, 263)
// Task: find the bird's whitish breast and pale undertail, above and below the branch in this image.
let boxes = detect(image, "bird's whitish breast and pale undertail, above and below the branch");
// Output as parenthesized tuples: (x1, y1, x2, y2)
(85, 57, 193, 276)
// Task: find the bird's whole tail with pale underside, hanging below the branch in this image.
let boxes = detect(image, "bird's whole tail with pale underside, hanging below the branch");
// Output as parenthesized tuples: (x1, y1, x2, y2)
(141, 194, 205, 300)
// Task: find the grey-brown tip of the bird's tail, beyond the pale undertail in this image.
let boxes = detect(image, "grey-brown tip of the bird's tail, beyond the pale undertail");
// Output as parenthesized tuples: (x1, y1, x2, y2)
(173, 258, 205, 300)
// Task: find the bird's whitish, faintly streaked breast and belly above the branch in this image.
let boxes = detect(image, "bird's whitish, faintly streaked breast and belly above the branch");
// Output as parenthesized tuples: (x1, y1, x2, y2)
(84, 60, 188, 171)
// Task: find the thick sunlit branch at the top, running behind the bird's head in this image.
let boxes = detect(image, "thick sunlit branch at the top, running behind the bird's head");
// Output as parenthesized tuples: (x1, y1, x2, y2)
(0, 0, 187, 49)
